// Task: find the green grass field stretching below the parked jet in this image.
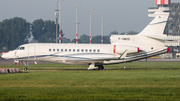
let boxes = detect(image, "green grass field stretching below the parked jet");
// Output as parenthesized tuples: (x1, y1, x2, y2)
(0, 62, 180, 101)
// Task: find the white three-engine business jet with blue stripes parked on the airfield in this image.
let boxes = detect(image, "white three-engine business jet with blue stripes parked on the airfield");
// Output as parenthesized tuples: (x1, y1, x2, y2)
(2, 7, 170, 71)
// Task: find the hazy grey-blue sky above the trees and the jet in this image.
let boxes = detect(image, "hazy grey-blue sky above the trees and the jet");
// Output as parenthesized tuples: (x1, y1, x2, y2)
(0, 0, 180, 39)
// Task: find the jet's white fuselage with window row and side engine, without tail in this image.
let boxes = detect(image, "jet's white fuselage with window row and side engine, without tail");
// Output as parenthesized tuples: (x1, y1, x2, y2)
(3, 43, 139, 65)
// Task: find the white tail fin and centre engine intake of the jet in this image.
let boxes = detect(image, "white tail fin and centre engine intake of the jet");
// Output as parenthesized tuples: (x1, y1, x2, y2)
(111, 5, 169, 51)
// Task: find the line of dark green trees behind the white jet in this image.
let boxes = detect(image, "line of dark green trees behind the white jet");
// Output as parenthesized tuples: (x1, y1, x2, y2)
(0, 17, 137, 51)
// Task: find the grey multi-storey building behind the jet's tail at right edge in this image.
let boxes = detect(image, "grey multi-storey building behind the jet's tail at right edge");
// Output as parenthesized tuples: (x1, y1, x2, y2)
(164, 3, 180, 58)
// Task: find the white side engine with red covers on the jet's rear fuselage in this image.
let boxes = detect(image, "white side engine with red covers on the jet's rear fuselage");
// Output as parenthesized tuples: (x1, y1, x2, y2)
(113, 45, 139, 54)
